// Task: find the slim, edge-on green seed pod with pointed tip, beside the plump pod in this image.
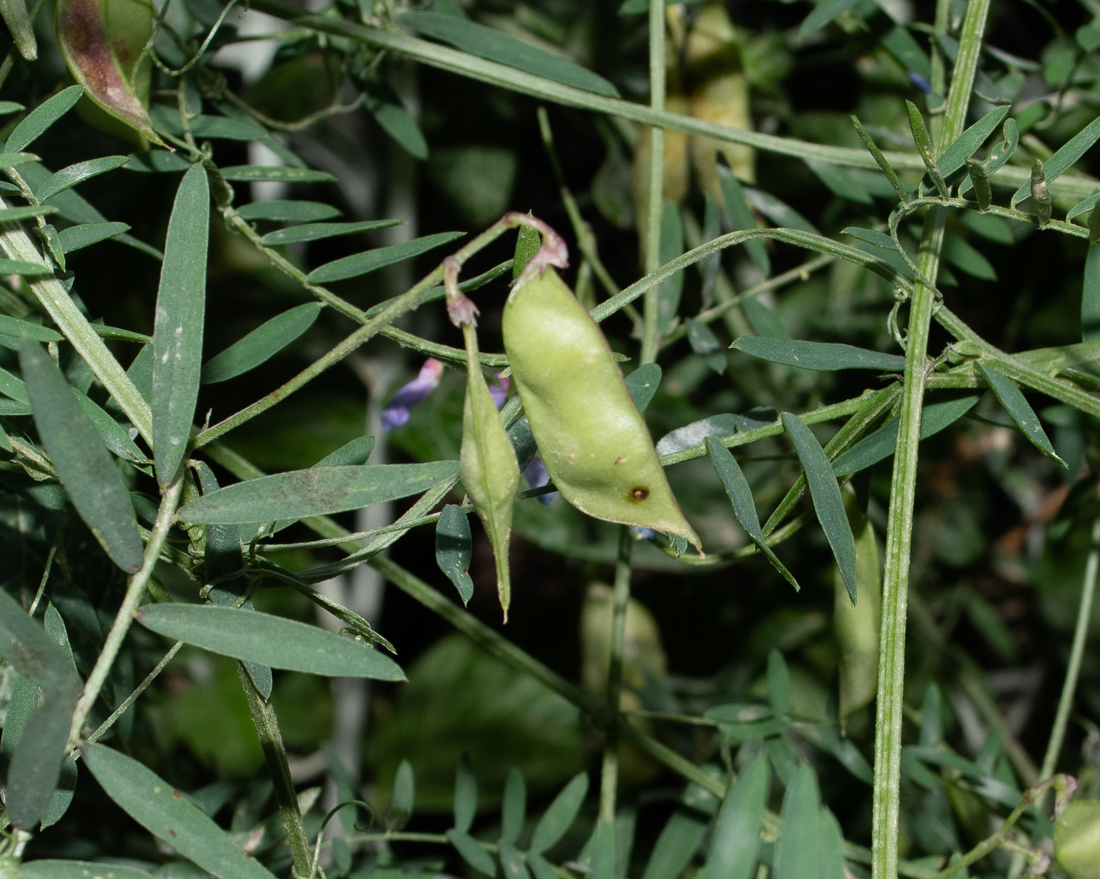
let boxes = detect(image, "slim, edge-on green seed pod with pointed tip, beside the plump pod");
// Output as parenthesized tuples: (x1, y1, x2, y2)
(460, 323, 519, 623)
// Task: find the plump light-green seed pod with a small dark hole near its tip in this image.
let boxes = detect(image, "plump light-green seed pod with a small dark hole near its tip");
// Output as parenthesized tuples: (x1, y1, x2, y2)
(503, 268, 701, 549)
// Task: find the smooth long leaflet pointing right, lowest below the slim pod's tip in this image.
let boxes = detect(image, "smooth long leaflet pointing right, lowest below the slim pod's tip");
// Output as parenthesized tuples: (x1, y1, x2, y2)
(135, 604, 405, 681)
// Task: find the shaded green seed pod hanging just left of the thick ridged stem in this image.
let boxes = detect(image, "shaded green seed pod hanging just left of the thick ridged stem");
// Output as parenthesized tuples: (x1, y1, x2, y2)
(833, 490, 882, 719)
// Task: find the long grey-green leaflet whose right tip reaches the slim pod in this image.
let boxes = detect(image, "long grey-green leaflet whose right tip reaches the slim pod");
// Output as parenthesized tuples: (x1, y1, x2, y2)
(178, 461, 459, 525)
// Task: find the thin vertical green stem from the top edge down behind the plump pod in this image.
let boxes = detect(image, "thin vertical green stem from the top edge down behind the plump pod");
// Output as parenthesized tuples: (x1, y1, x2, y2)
(641, 0, 664, 363)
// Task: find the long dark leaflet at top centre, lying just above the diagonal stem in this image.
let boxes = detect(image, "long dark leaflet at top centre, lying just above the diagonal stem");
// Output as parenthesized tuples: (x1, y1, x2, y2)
(396, 11, 618, 98)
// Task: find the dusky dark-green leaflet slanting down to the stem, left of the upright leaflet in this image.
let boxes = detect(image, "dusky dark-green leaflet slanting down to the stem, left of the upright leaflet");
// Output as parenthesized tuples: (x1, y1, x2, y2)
(19, 340, 144, 573)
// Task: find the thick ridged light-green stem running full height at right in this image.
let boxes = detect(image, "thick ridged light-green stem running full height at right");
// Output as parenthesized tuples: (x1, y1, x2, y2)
(871, 0, 989, 879)
